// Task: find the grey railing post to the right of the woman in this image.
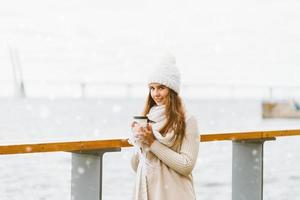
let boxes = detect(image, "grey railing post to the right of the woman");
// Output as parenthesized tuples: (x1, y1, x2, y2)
(232, 138, 275, 200)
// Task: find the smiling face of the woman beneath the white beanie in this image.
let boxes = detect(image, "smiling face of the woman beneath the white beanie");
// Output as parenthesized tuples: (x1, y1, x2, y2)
(149, 83, 169, 105)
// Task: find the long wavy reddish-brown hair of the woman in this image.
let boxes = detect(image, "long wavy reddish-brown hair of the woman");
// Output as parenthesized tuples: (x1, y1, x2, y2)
(143, 88, 186, 147)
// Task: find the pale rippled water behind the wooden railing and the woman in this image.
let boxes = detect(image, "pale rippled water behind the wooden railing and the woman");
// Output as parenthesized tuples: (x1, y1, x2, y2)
(0, 98, 300, 200)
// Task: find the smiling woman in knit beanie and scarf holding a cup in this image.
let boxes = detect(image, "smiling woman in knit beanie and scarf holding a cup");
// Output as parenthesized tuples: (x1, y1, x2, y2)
(131, 55, 199, 200)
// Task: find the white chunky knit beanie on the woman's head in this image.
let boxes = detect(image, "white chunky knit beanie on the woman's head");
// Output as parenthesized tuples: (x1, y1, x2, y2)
(148, 55, 181, 94)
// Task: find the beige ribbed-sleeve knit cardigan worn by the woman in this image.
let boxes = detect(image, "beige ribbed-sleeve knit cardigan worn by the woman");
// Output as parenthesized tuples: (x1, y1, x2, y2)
(131, 116, 199, 200)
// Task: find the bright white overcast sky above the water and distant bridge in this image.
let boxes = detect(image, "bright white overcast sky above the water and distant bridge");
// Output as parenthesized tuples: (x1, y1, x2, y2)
(0, 0, 300, 86)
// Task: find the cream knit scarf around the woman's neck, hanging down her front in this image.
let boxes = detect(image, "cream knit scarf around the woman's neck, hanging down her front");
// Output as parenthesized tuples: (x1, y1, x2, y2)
(135, 105, 175, 200)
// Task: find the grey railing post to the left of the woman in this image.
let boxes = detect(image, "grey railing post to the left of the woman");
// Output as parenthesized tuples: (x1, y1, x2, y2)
(71, 148, 121, 200)
